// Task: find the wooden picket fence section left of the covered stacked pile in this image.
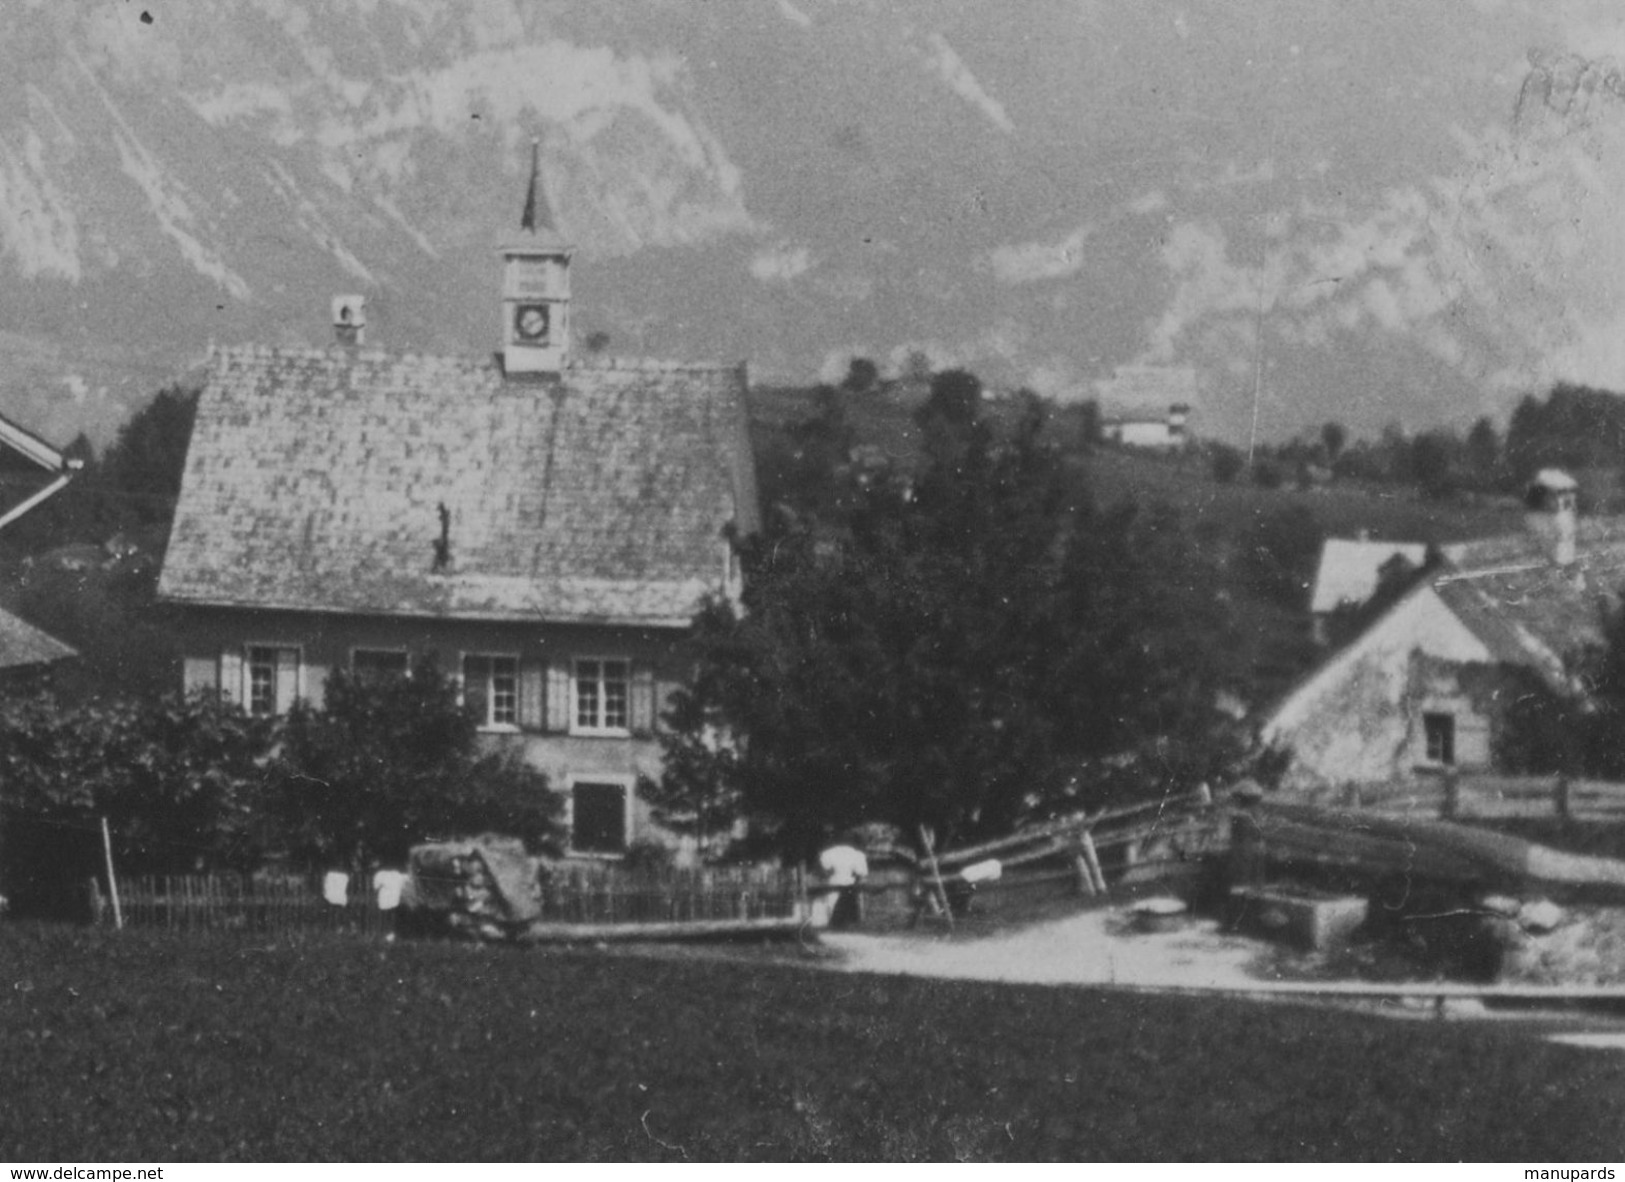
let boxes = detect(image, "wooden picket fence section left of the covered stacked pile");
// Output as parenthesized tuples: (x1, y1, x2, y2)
(112, 875, 392, 935)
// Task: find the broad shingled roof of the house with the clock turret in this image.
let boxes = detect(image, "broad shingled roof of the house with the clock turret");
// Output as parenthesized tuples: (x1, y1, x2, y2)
(159, 348, 757, 626)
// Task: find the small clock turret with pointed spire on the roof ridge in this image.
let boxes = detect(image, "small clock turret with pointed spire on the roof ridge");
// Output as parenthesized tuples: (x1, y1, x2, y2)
(502, 140, 575, 374)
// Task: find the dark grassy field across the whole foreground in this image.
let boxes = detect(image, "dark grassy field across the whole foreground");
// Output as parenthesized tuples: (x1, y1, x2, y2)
(0, 923, 1625, 1164)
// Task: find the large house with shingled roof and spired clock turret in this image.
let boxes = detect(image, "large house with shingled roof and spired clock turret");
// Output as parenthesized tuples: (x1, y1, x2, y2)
(159, 166, 757, 855)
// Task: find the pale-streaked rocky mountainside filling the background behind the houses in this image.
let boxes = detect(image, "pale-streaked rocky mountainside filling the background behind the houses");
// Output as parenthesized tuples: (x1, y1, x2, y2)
(0, 0, 1625, 442)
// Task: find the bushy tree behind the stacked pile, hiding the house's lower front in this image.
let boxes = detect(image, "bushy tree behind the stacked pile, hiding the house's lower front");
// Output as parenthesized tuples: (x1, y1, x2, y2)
(270, 662, 559, 870)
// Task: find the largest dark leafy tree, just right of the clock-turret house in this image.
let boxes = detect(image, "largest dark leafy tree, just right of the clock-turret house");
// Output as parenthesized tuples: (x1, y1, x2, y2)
(657, 372, 1225, 854)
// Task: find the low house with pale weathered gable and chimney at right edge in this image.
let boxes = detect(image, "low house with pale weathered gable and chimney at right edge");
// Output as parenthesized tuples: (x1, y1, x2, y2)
(1261, 471, 1625, 787)
